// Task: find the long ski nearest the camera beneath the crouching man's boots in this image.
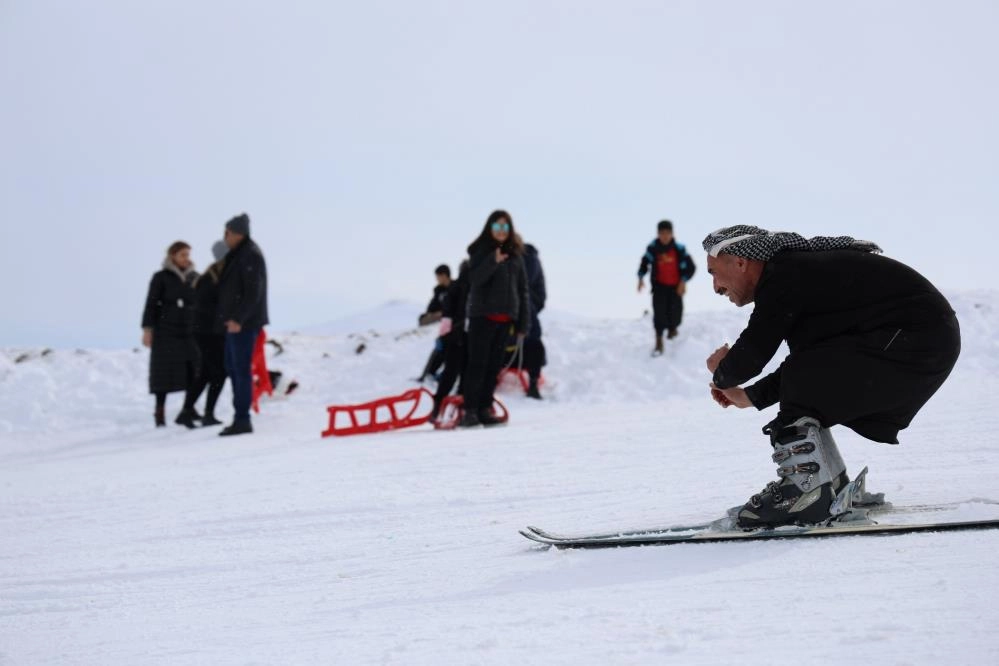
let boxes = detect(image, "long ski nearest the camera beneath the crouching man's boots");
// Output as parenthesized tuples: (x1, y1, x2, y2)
(520, 519, 999, 548)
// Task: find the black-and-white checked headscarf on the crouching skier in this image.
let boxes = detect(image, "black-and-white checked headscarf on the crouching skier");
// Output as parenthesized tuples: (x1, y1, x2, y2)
(702, 224, 881, 261)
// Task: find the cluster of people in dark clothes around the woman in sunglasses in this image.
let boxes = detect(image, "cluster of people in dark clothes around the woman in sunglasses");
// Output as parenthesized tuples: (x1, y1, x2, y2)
(420, 210, 547, 428)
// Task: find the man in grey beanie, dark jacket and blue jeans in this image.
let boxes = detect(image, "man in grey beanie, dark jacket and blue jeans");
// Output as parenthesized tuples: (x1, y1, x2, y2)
(217, 213, 270, 436)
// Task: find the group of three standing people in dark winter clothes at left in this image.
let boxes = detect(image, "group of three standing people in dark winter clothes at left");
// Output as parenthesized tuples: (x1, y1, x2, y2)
(142, 213, 269, 436)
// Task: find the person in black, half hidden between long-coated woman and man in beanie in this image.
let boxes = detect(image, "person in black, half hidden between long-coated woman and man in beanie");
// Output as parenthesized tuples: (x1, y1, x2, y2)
(177, 241, 229, 428)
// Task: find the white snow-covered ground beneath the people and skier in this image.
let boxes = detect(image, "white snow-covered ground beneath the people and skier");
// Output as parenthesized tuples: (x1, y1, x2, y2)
(0, 291, 999, 666)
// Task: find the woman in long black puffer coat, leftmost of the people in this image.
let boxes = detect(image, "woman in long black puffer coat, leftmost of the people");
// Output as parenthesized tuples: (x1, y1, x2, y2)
(142, 241, 200, 427)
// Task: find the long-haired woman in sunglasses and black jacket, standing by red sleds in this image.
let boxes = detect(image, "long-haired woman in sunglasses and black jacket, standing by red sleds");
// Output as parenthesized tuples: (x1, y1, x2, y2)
(461, 210, 531, 427)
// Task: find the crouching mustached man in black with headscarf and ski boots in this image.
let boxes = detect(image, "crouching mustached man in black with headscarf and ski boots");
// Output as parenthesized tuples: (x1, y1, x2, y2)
(703, 225, 961, 527)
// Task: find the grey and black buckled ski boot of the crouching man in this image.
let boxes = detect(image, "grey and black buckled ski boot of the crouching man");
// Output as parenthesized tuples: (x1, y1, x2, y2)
(737, 416, 850, 528)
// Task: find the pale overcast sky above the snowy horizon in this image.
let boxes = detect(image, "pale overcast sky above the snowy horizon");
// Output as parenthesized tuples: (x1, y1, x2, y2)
(0, 0, 999, 347)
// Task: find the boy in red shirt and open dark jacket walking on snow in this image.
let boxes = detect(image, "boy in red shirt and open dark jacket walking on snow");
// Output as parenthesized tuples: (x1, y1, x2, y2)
(638, 220, 696, 355)
